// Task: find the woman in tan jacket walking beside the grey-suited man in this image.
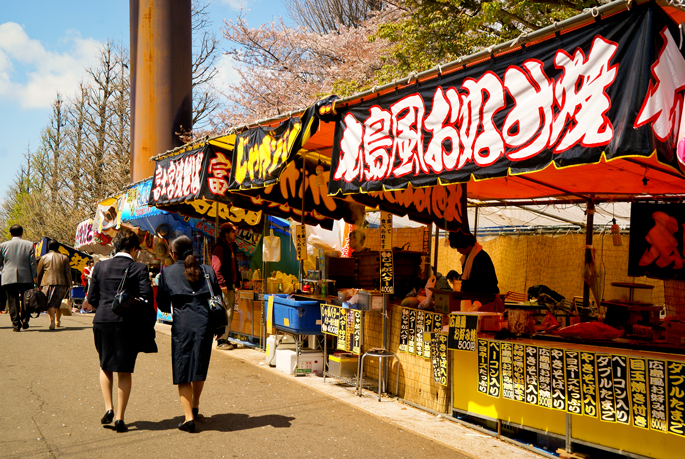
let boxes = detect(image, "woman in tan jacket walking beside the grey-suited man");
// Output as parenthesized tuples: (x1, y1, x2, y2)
(37, 241, 71, 330)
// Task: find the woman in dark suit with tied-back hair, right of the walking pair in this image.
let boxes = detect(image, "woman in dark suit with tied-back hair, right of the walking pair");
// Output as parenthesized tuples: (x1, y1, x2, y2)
(157, 236, 220, 432)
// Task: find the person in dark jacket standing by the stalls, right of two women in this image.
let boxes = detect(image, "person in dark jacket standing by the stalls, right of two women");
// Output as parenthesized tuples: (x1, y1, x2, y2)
(212, 222, 240, 351)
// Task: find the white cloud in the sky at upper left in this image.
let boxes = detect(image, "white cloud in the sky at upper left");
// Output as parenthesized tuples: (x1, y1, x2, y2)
(0, 22, 100, 108)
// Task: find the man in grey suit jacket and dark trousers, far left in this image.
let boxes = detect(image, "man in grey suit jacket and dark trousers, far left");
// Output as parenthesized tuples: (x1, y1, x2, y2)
(0, 225, 37, 332)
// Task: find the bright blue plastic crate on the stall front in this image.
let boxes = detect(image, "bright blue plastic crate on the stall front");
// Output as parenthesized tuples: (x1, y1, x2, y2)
(264, 294, 323, 335)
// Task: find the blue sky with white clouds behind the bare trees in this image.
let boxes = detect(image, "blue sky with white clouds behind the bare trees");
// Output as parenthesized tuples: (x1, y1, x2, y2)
(0, 0, 289, 201)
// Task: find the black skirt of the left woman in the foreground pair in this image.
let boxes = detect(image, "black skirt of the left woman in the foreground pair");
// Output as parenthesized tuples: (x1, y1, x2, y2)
(93, 322, 139, 373)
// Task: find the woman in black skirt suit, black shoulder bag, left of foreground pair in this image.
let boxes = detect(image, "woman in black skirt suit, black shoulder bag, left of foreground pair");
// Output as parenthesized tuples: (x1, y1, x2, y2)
(87, 228, 157, 432)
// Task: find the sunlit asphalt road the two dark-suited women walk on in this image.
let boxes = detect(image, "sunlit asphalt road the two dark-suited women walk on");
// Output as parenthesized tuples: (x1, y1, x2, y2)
(0, 314, 471, 459)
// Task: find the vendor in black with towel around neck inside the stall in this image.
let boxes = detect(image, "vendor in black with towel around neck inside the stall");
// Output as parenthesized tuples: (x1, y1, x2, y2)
(449, 231, 499, 294)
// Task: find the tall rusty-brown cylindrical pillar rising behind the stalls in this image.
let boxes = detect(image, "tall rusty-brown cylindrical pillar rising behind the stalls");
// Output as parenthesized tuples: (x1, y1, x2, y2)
(129, 0, 192, 182)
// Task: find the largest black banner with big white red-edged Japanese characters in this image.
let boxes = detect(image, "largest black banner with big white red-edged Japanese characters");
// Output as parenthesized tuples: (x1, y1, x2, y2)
(329, 2, 685, 195)
